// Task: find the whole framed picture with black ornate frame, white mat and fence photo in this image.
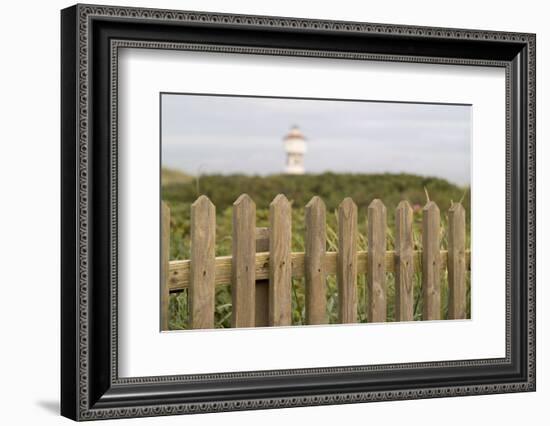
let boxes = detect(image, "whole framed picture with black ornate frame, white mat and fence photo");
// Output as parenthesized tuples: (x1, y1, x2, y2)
(61, 5, 535, 420)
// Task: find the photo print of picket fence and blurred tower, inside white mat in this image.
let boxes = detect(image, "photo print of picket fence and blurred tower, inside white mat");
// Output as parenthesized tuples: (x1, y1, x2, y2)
(160, 93, 475, 331)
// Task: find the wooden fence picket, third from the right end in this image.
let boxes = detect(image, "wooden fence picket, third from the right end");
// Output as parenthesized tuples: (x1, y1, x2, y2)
(395, 201, 414, 321)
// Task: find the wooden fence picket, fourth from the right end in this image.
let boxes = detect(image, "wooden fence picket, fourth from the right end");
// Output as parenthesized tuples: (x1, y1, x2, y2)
(367, 199, 387, 322)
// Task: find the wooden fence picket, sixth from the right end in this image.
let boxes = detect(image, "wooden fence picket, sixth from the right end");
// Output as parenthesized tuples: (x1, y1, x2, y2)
(304, 197, 327, 324)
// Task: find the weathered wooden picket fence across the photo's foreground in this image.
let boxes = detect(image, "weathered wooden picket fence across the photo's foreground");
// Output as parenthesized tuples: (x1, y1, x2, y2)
(161, 194, 470, 330)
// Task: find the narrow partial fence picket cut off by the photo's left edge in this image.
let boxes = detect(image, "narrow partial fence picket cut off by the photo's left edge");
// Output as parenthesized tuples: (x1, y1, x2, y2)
(160, 202, 170, 331)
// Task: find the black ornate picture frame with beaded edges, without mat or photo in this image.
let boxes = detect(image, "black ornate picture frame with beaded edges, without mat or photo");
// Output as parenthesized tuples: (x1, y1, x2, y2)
(61, 5, 535, 420)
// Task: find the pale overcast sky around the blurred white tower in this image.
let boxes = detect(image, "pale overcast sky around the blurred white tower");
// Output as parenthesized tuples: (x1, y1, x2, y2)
(161, 94, 472, 185)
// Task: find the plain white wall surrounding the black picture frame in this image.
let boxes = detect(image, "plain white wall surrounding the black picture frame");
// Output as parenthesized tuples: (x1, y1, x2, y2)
(0, 0, 550, 426)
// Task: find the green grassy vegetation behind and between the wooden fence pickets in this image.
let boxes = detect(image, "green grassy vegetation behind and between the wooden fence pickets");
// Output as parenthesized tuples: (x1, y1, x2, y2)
(162, 170, 470, 329)
